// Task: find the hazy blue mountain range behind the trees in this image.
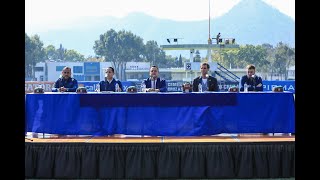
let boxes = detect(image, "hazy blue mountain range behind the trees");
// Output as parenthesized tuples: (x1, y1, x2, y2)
(27, 0, 295, 56)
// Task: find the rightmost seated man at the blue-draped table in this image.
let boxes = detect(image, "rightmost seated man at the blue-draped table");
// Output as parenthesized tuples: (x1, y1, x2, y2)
(240, 64, 263, 91)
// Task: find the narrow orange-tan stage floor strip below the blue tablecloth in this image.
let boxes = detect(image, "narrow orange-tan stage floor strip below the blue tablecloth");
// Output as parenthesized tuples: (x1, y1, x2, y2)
(25, 133, 295, 143)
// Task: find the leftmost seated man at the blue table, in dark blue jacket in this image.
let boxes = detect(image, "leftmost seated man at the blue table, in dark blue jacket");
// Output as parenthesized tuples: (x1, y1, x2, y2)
(52, 66, 78, 92)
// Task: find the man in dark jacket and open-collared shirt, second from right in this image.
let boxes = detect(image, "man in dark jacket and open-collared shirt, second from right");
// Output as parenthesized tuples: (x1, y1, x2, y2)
(192, 63, 219, 92)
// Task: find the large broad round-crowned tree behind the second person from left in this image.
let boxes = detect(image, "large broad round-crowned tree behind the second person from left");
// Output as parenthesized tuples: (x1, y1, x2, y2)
(93, 29, 144, 80)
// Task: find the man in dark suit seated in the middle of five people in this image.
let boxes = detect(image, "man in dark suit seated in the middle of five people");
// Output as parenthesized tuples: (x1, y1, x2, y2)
(142, 66, 167, 92)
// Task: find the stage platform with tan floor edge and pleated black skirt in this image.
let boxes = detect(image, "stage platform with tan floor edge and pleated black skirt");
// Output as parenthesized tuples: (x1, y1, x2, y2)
(25, 133, 295, 179)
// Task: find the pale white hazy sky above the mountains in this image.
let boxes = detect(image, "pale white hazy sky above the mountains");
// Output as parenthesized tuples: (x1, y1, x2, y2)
(25, 0, 295, 34)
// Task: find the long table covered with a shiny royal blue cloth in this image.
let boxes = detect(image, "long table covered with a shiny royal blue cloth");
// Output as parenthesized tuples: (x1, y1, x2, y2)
(25, 92, 295, 136)
